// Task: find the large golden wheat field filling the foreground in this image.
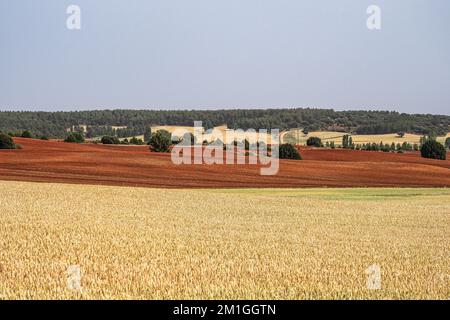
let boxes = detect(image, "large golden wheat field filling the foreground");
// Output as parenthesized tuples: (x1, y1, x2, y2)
(0, 182, 450, 299)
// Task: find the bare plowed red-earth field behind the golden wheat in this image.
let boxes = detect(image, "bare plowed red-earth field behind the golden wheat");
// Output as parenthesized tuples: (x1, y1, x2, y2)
(0, 138, 450, 188)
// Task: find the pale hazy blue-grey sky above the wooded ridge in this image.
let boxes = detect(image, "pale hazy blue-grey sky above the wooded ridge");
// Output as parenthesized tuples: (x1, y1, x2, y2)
(0, 0, 450, 114)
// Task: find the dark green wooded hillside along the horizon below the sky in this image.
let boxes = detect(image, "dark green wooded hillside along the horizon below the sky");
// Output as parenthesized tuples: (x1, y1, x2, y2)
(0, 108, 450, 138)
